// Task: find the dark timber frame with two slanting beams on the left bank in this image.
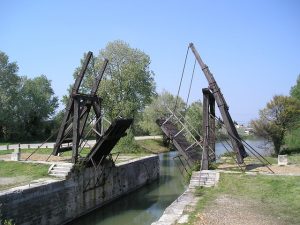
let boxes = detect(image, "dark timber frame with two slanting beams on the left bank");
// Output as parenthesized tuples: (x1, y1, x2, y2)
(52, 52, 108, 163)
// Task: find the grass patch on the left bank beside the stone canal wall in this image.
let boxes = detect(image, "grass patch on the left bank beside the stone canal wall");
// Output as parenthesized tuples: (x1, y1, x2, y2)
(0, 161, 49, 190)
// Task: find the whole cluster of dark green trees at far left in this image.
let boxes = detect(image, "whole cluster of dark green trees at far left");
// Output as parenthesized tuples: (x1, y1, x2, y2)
(0, 52, 58, 140)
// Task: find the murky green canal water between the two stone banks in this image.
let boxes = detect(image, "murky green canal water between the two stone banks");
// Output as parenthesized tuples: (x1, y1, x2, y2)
(70, 151, 185, 225)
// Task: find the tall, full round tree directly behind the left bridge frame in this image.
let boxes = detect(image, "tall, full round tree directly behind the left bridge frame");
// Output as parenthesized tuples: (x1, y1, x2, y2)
(74, 41, 156, 120)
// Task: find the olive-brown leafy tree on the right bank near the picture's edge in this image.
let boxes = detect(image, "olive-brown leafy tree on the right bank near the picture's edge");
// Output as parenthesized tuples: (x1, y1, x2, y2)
(251, 95, 300, 155)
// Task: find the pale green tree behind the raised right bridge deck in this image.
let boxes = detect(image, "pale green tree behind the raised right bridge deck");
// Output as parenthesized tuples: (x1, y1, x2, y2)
(139, 91, 186, 135)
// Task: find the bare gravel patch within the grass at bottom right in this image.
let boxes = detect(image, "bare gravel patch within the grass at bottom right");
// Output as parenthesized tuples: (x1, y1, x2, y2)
(196, 195, 285, 225)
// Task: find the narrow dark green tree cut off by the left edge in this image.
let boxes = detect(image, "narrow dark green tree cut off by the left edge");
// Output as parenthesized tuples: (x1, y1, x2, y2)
(0, 51, 20, 140)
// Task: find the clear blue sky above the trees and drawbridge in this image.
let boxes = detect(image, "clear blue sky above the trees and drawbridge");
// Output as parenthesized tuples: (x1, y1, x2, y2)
(0, 0, 300, 124)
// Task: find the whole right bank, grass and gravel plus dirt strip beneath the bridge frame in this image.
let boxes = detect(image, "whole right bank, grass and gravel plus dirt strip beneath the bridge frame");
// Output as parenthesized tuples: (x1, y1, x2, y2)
(169, 151, 300, 225)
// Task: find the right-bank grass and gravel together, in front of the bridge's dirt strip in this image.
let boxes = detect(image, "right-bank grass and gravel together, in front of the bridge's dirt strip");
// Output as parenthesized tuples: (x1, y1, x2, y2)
(184, 173, 300, 225)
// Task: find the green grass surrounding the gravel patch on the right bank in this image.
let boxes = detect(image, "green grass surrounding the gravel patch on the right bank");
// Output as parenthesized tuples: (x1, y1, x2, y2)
(188, 174, 300, 224)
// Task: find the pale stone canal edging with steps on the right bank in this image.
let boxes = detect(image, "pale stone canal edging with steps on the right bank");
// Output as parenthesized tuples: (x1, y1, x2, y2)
(151, 170, 220, 225)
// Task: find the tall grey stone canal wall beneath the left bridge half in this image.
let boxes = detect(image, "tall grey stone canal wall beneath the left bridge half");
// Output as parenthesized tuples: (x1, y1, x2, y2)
(0, 156, 159, 225)
